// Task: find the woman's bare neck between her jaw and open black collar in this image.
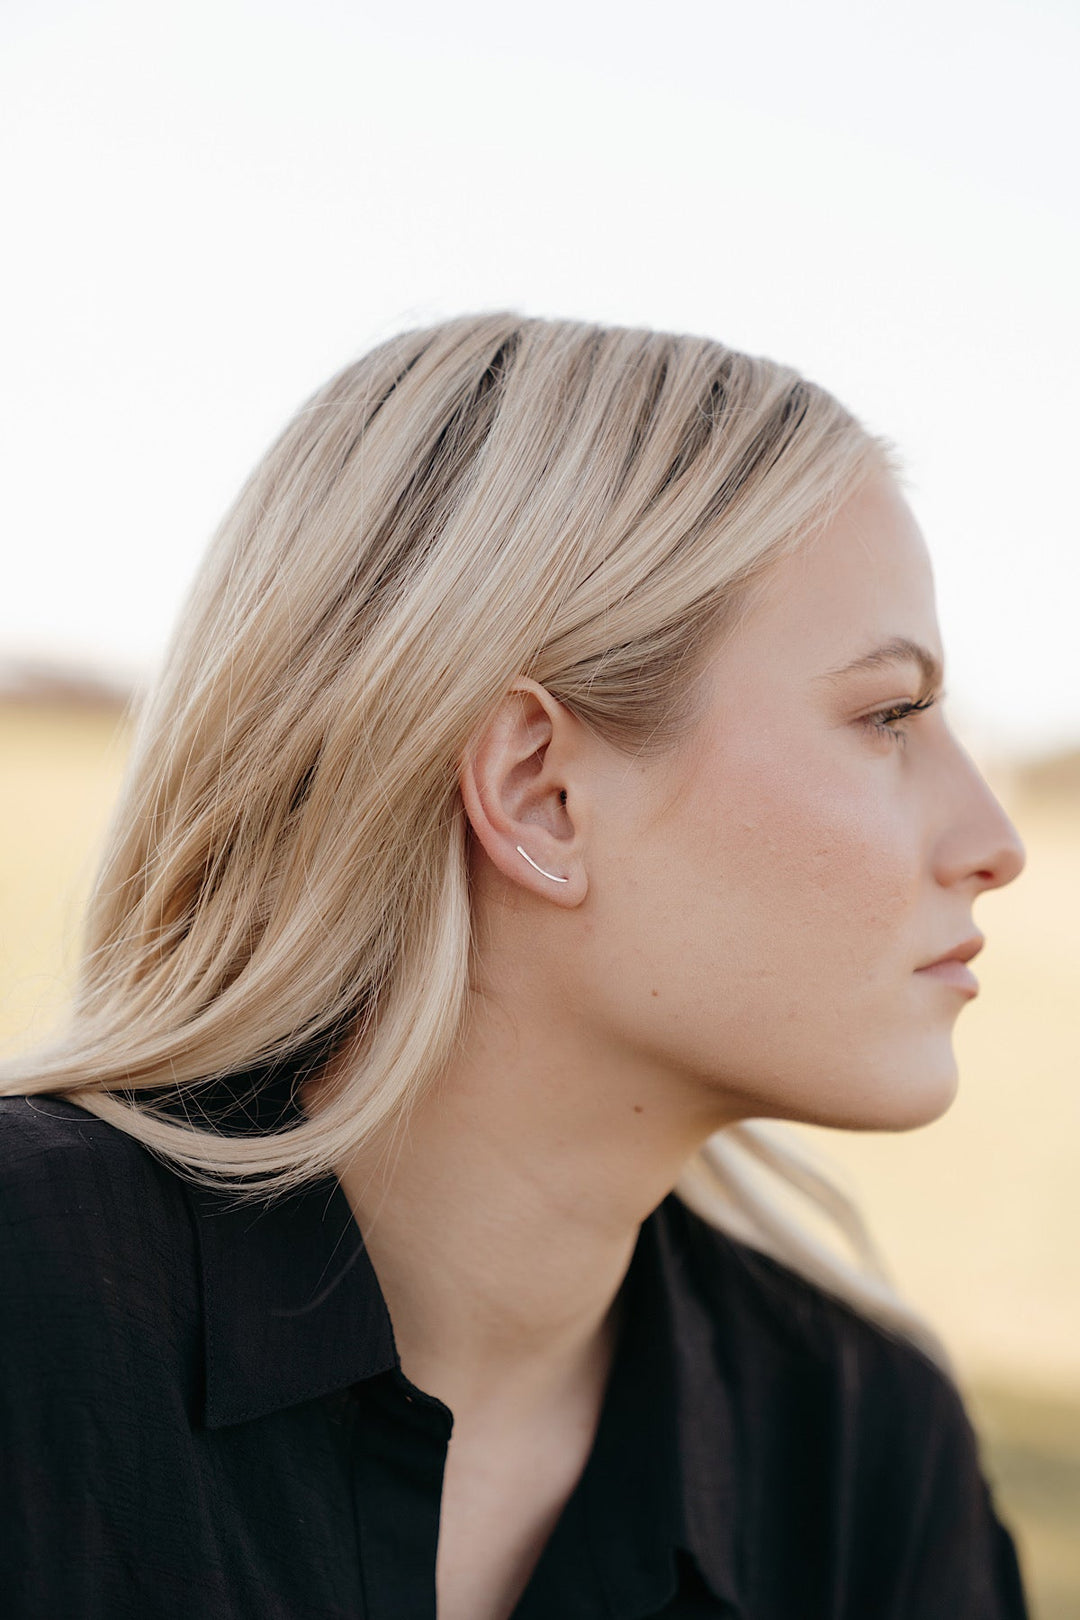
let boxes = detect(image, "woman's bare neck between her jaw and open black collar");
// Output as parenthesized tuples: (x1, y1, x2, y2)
(312, 984, 735, 1413)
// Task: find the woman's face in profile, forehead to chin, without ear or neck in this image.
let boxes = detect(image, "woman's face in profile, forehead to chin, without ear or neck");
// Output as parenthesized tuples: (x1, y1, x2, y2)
(563, 475, 1025, 1129)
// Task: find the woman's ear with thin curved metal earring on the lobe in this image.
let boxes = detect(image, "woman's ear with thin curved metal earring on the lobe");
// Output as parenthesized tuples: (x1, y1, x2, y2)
(458, 677, 588, 906)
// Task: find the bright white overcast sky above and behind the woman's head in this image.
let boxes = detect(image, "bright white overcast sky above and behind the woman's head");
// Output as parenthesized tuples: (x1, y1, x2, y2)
(0, 0, 1080, 750)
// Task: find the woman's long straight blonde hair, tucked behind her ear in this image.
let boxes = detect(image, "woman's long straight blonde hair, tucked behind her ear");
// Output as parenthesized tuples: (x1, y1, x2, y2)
(2, 313, 949, 1367)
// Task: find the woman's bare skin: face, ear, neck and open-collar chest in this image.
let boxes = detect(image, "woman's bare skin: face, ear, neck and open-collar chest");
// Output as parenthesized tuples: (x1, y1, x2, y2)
(317, 473, 1025, 1615)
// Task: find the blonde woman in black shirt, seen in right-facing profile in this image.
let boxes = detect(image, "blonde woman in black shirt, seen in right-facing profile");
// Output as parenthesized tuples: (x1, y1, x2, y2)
(0, 313, 1025, 1620)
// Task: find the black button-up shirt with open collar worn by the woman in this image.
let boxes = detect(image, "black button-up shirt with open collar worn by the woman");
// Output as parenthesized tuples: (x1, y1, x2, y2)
(0, 1097, 1027, 1620)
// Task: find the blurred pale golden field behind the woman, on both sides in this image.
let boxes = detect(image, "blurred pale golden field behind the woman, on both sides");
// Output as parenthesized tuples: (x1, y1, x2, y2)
(0, 701, 1080, 1620)
